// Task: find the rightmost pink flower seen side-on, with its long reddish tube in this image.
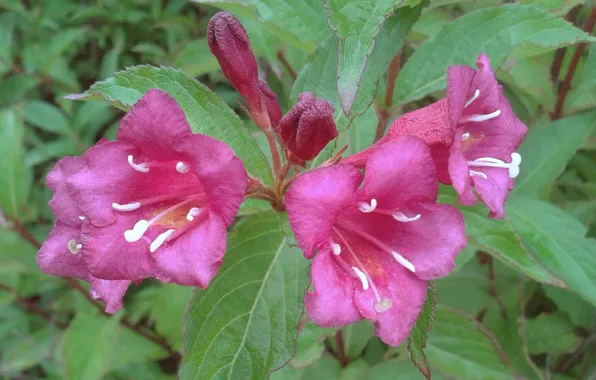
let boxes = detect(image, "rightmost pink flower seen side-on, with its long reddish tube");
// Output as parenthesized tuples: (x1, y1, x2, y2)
(344, 54, 527, 218)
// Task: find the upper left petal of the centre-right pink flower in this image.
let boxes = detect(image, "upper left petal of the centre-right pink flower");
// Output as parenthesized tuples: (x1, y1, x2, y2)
(285, 165, 362, 258)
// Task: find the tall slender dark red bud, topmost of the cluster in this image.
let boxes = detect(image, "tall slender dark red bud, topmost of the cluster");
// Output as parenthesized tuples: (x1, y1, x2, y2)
(207, 12, 264, 119)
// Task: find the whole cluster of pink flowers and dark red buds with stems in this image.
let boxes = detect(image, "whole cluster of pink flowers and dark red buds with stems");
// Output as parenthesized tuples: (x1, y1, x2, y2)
(38, 12, 526, 345)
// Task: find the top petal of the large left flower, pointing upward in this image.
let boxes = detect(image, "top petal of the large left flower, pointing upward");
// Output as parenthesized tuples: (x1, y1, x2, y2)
(118, 88, 191, 161)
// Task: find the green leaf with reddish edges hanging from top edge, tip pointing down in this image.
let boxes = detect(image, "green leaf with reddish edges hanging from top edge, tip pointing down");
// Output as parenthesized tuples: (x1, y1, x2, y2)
(323, 0, 399, 115)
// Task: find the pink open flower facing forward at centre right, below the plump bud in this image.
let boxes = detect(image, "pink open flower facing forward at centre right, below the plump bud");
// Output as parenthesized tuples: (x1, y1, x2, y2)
(286, 136, 466, 345)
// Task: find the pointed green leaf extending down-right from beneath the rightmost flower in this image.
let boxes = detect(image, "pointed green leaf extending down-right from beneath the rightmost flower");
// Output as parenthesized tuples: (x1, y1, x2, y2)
(439, 187, 564, 286)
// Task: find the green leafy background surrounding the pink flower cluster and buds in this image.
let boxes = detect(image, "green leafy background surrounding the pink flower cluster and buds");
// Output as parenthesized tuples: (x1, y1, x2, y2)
(0, 0, 596, 380)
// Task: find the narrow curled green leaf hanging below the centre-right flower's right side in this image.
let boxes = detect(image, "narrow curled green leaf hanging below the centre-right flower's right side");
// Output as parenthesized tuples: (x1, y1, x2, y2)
(408, 281, 437, 380)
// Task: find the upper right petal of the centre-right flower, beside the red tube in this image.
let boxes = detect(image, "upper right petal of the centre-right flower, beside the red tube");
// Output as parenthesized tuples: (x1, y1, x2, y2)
(359, 136, 438, 210)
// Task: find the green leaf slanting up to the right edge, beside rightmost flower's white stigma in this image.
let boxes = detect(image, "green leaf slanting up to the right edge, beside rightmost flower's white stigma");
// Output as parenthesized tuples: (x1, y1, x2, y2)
(513, 112, 596, 198)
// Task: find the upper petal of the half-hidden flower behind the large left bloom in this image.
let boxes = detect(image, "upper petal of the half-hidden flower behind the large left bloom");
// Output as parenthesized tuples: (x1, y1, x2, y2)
(46, 157, 85, 227)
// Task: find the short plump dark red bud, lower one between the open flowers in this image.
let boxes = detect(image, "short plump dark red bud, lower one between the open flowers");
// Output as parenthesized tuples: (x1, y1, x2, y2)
(276, 92, 337, 163)
